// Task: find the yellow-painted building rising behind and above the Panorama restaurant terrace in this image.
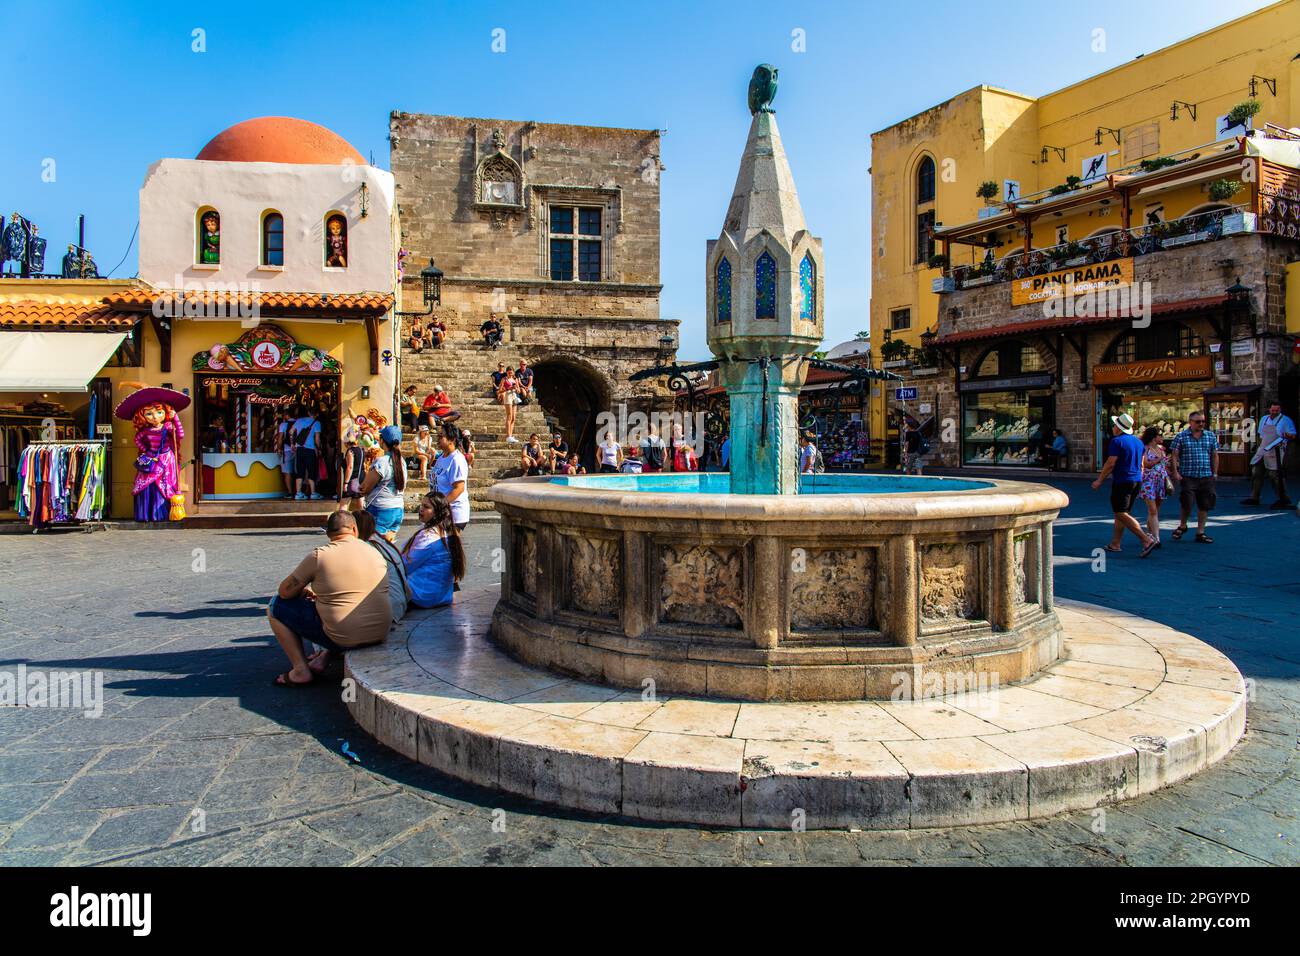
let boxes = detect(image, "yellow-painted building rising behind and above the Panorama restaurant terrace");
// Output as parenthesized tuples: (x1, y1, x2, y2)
(871, 0, 1300, 462)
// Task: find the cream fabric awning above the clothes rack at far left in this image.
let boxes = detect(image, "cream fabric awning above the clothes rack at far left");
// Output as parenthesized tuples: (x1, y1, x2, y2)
(0, 332, 126, 392)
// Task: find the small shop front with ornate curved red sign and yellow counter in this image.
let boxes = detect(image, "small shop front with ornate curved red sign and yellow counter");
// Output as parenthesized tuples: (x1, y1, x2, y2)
(192, 324, 342, 501)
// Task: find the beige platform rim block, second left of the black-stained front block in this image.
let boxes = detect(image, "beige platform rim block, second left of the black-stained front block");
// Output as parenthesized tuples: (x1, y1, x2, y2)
(498, 717, 645, 813)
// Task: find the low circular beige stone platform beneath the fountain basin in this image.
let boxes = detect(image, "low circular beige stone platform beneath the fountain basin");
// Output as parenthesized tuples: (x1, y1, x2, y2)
(347, 587, 1245, 830)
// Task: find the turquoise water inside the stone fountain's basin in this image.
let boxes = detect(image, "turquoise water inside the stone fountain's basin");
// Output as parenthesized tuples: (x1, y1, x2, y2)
(551, 471, 993, 494)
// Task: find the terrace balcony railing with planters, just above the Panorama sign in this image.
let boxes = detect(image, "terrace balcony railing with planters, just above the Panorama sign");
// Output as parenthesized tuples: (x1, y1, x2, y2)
(933, 206, 1255, 293)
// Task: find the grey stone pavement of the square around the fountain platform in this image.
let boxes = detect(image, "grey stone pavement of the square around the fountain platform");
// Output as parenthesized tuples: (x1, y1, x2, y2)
(0, 479, 1300, 866)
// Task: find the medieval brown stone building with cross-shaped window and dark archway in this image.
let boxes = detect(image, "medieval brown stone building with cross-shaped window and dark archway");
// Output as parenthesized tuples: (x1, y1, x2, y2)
(390, 112, 677, 497)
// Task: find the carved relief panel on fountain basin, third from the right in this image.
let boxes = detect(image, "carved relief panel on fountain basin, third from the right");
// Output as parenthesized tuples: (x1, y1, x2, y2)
(789, 548, 879, 631)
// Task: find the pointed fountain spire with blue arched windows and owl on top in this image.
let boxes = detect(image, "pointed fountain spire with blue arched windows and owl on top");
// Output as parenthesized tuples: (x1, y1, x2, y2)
(705, 64, 824, 494)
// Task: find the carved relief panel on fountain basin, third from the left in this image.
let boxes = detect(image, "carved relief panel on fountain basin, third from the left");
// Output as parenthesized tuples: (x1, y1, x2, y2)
(659, 544, 745, 628)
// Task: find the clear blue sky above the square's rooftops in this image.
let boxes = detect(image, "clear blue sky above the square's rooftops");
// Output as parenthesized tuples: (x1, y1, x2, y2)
(0, 0, 1266, 358)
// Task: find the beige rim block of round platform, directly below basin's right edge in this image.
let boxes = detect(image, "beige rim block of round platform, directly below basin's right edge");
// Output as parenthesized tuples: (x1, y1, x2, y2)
(985, 727, 1138, 817)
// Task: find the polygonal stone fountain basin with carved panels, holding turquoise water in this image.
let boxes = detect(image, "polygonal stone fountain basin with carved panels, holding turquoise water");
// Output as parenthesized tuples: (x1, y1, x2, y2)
(490, 473, 1069, 701)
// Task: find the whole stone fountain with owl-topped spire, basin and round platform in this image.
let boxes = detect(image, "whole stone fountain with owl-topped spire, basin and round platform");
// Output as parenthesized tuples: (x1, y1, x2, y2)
(346, 66, 1245, 829)
